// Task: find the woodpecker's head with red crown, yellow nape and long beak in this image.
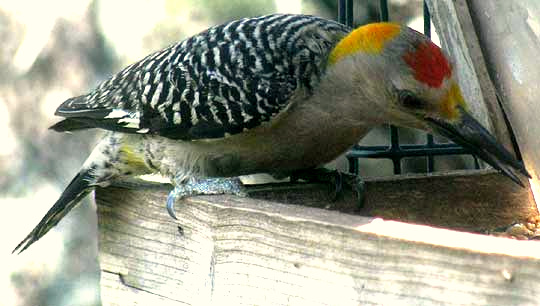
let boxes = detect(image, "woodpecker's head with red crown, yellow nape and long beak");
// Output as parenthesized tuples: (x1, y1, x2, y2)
(329, 23, 530, 186)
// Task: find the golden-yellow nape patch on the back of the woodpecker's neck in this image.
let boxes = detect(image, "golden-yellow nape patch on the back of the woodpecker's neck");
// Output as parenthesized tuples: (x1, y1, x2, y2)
(328, 22, 401, 64)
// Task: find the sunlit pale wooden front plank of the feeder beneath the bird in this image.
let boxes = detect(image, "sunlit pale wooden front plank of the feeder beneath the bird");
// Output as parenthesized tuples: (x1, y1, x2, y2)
(96, 173, 540, 305)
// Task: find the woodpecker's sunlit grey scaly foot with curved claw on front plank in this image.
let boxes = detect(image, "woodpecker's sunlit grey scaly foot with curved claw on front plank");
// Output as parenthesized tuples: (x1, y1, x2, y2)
(167, 177, 247, 220)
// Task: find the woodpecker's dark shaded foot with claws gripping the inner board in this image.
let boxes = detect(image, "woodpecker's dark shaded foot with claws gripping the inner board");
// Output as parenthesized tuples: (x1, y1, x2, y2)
(291, 168, 366, 209)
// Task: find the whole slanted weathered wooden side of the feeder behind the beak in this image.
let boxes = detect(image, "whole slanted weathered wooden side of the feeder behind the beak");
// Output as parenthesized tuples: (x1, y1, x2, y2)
(426, 0, 540, 210)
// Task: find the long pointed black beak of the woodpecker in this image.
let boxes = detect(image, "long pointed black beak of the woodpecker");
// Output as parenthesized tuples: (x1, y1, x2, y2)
(425, 107, 531, 187)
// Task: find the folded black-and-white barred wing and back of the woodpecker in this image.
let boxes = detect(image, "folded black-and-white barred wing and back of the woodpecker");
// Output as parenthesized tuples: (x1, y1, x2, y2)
(51, 14, 350, 140)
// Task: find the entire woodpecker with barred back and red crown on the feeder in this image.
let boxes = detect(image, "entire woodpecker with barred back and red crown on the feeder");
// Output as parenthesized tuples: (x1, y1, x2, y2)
(14, 14, 528, 252)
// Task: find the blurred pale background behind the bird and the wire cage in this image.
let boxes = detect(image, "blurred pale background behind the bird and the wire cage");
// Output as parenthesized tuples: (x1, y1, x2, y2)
(0, 0, 461, 306)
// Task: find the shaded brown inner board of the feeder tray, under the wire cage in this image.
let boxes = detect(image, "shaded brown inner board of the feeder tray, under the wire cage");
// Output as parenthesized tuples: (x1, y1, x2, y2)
(250, 170, 538, 232)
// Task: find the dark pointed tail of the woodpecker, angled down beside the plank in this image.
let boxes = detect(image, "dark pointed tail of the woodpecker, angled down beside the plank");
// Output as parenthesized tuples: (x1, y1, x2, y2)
(12, 170, 93, 254)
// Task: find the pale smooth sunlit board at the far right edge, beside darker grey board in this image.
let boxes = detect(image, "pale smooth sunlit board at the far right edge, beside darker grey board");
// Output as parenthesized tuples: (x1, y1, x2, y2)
(468, 0, 540, 210)
